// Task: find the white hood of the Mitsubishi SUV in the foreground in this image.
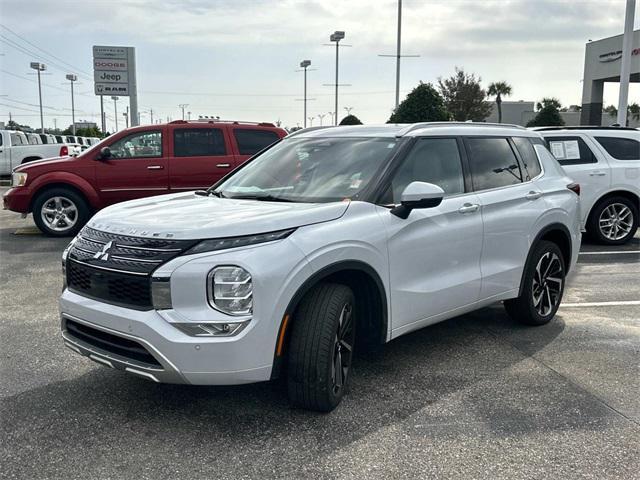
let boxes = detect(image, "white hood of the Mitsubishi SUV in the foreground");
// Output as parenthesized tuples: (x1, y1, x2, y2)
(88, 192, 349, 239)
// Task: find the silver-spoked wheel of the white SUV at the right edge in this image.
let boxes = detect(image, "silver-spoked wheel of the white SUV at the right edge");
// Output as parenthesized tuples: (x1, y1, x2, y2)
(587, 197, 638, 245)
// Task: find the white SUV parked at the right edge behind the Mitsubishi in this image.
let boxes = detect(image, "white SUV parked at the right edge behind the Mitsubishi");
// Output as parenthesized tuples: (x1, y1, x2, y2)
(536, 127, 640, 245)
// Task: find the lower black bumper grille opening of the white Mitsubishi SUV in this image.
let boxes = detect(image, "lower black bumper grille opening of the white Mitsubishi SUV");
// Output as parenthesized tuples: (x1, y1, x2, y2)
(65, 319, 162, 368)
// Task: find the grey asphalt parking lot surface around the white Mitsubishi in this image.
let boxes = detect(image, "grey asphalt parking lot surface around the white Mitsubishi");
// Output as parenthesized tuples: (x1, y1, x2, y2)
(0, 189, 640, 479)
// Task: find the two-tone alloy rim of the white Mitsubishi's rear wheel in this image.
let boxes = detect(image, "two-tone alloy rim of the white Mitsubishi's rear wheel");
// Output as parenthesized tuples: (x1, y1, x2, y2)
(531, 252, 564, 317)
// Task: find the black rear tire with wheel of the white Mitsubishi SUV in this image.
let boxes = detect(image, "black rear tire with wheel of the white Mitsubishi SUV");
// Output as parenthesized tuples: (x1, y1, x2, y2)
(504, 240, 566, 325)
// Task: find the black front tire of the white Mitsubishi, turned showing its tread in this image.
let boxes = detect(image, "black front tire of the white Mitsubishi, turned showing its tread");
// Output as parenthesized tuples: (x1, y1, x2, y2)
(287, 283, 356, 412)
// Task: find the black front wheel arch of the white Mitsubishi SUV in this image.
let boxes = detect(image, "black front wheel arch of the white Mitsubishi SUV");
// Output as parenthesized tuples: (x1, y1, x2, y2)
(271, 260, 389, 378)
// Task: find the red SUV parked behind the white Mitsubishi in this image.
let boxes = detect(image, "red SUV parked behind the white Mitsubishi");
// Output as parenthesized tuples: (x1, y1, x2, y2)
(3, 120, 287, 236)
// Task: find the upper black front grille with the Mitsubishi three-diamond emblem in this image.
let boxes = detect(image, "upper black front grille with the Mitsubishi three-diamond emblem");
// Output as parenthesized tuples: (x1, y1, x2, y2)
(67, 227, 196, 310)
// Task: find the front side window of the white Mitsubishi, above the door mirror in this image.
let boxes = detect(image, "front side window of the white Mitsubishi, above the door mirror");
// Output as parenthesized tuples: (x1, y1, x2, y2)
(383, 138, 464, 204)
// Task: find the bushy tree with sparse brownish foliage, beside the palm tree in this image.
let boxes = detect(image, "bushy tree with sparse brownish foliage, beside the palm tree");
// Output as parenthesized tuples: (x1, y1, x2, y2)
(438, 67, 491, 122)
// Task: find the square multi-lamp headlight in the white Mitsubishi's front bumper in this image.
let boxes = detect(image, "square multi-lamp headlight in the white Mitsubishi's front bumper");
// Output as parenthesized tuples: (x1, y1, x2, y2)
(207, 266, 253, 316)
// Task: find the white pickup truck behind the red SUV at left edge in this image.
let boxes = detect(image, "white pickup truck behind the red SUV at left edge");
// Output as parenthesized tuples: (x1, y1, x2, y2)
(0, 130, 76, 176)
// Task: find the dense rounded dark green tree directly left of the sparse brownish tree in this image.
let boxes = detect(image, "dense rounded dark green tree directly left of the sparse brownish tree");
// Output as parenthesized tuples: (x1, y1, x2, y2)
(387, 82, 450, 123)
